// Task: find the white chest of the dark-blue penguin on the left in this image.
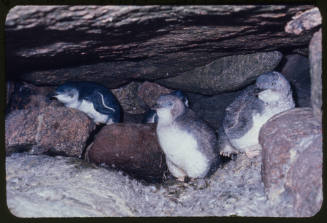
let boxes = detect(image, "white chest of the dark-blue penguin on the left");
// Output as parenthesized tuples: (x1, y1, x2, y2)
(67, 100, 108, 123)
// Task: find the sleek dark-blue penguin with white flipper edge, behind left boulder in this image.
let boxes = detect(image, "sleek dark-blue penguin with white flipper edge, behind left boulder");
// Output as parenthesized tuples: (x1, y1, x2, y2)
(51, 82, 120, 125)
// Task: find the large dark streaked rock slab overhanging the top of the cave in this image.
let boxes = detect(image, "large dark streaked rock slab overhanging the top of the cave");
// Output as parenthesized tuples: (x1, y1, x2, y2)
(5, 5, 316, 88)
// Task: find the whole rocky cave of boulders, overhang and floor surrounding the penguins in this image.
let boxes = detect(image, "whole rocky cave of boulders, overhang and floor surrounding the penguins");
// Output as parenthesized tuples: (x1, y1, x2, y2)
(5, 5, 322, 217)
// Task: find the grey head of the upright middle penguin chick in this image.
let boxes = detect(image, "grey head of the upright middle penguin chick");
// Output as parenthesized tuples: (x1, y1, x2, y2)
(153, 94, 186, 123)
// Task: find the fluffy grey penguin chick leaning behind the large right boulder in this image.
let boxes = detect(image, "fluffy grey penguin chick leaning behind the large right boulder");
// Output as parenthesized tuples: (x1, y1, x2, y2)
(219, 71, 295, 158)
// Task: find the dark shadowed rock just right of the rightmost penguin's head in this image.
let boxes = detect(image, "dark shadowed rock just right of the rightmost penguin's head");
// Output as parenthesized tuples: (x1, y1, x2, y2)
(281, 54, 311, 107)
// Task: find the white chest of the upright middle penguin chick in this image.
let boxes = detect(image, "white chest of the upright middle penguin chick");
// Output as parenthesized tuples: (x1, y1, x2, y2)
(157, 125, 203, 164)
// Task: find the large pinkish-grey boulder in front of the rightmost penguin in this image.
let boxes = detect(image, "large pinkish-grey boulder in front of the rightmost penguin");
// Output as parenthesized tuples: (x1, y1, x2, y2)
(259, 108, 323, 217)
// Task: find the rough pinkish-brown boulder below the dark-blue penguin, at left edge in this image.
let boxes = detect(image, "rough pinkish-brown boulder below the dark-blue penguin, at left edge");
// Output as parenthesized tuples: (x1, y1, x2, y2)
(5, 104, 95, 157)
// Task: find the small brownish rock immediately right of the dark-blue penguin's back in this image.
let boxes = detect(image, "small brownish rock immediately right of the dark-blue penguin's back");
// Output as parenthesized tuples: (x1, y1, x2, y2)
(111, 82, 146, 114)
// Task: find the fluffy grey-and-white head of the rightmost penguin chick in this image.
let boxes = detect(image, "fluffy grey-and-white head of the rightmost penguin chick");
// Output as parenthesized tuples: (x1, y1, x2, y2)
(256, 71, 291, 103)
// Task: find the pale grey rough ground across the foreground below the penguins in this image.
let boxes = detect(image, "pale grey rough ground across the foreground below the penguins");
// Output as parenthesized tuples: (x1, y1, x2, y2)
(6, 153, 300, 217)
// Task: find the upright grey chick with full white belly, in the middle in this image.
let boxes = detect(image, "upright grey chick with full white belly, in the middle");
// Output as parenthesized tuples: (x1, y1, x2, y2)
(155, 94, 220, 181)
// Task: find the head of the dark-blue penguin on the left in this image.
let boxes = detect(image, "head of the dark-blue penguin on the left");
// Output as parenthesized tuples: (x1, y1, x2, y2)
(52, 83, 78, 104)
